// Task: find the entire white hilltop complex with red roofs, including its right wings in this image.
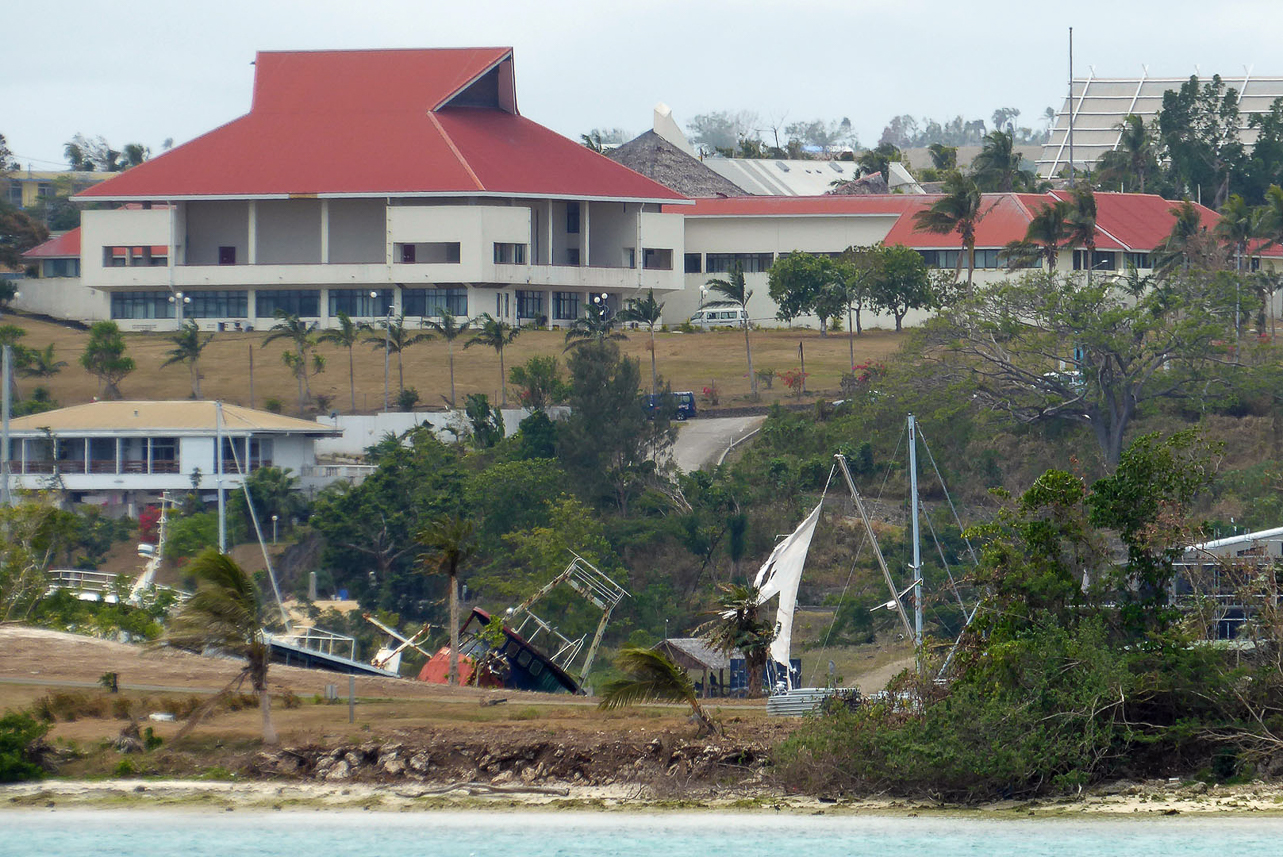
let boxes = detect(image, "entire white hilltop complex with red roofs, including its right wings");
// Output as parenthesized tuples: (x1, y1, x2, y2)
(14, 47, 1280, 330)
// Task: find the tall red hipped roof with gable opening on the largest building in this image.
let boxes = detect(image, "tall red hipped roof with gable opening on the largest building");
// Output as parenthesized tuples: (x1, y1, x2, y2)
(78, 47, 684, 203)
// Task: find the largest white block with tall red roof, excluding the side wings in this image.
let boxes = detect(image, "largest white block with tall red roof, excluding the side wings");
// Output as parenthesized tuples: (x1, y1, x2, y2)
(67, 47, 685, 330)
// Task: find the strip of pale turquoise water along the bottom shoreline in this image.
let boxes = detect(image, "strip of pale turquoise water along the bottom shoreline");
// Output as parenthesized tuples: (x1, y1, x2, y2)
(0, 810, 1283, 857)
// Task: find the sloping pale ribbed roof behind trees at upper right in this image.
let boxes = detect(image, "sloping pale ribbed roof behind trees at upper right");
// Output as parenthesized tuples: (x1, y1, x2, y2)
(1038, 69, 1283, 178)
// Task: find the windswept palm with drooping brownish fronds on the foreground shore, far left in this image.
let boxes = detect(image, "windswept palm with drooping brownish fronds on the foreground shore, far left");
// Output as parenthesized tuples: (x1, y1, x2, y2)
(158, 548, 276, 744)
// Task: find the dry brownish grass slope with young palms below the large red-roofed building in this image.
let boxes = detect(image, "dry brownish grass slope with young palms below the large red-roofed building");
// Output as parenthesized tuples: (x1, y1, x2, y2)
(4, 313, 903, 413)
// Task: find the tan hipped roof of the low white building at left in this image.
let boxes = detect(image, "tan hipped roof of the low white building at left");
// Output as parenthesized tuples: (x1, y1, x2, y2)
(9, 400, 343, 435)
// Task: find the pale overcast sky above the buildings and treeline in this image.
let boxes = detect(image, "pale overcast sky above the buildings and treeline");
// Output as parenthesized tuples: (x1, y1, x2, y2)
(0, 0, 1283, 169)
